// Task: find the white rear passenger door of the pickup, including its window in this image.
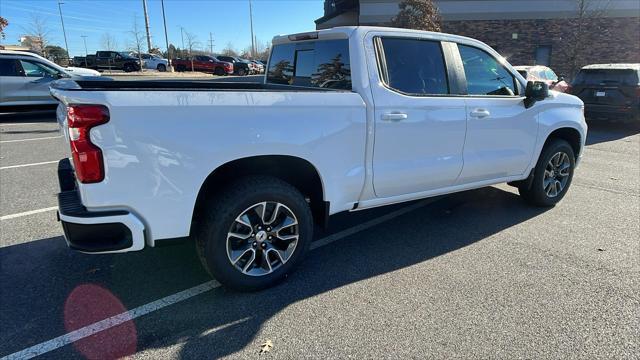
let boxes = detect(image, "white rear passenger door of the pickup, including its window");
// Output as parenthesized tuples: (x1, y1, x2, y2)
(367, 34, 466, 197)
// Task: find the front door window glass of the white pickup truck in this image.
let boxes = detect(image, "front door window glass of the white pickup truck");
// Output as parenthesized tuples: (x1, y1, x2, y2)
(458, 45, 516, 95)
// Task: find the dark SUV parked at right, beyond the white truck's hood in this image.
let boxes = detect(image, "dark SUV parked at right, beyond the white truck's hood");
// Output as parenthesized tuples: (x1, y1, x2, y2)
(570, 64, 640, 120)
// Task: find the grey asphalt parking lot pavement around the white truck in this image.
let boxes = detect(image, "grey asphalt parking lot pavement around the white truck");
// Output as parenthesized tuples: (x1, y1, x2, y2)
(0, 112, 640, 359)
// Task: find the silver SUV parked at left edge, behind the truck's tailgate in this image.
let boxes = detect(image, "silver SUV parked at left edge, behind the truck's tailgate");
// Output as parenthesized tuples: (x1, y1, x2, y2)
(0, 50, 106, 110)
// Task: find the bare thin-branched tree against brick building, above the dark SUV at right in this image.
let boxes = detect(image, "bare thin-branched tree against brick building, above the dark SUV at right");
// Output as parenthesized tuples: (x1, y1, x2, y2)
(565, 0, 611, 77)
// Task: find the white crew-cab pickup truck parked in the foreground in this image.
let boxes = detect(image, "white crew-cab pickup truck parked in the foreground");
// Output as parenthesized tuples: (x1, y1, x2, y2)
(51, 27, 587, 290)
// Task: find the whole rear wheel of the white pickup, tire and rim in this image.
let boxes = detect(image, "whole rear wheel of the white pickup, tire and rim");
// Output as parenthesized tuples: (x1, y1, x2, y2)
(196, 176, 313, 291)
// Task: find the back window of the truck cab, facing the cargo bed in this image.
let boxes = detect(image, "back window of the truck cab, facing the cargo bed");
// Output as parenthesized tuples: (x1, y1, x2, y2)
(267, 39, 351, 90)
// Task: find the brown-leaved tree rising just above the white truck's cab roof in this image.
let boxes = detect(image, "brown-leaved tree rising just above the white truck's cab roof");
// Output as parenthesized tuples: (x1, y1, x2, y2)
(391, 0, 442, 31)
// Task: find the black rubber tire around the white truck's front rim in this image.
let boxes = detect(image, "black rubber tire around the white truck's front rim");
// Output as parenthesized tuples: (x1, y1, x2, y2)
(518, 139, 576, 207)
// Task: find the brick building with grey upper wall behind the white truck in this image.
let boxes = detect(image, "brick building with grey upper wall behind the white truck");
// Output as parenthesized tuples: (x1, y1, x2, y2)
(316, 0, 640, 76)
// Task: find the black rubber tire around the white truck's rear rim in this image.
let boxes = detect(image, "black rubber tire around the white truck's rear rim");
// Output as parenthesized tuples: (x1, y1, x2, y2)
(195, 176, 313, 291)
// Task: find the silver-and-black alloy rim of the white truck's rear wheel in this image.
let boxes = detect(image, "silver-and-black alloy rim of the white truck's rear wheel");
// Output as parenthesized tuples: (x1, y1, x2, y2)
(227, 201, 300, 276)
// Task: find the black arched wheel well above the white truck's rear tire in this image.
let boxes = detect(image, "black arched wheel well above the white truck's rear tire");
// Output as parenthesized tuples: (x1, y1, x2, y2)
(191, 155, 329, 233)
